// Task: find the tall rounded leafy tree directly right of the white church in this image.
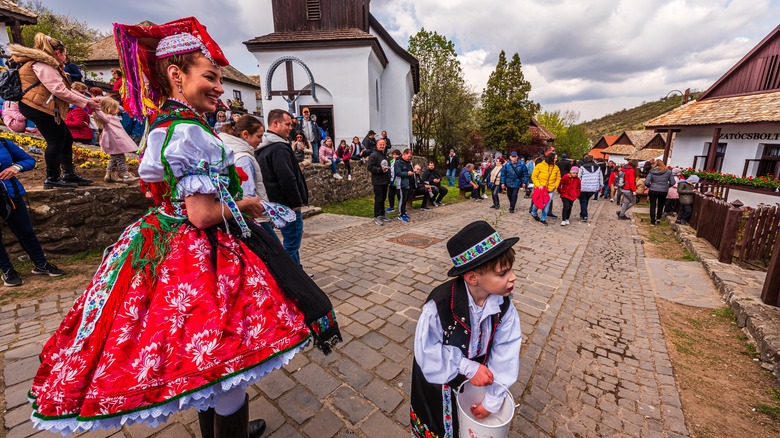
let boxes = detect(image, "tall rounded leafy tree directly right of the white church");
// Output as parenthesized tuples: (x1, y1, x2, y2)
(409, 29, 477, 164)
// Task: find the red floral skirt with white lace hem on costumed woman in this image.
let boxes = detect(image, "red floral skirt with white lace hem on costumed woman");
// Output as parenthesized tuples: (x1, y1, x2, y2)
(30, 213, 310, 433)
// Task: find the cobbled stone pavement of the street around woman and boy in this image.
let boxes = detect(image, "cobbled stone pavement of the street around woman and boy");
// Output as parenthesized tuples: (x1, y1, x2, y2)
(0, 198, 688, 438)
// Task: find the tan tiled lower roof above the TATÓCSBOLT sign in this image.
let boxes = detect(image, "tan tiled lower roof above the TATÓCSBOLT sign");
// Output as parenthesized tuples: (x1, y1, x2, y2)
(645, 91, 780, 129)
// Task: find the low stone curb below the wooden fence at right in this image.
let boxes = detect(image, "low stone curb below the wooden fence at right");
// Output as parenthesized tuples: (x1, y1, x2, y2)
(669, 221, 780, 385)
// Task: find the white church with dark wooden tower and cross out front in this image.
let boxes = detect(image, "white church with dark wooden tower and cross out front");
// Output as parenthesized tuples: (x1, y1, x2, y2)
(244, 0, 420, 148)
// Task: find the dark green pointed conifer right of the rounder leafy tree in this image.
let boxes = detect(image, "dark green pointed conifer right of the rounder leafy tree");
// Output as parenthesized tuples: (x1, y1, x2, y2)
(480, 50, 539, 150)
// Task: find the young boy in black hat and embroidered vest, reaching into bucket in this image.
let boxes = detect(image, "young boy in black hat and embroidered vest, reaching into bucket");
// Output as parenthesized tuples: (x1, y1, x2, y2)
(410, 221, 522, 438)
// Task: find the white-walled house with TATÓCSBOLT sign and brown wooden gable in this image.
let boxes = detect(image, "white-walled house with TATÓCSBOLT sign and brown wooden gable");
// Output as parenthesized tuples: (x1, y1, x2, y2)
(645, 26, 780, 178)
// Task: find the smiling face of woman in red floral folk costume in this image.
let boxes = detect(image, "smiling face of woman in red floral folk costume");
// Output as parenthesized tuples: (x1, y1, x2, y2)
(179, 55, 225, 113)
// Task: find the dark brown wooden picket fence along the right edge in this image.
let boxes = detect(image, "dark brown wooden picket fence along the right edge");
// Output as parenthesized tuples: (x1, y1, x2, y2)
(690, 190, 780, 307)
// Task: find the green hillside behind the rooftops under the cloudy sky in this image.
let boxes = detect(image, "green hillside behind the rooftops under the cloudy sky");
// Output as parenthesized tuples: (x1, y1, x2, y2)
(580, 92, 701, 142)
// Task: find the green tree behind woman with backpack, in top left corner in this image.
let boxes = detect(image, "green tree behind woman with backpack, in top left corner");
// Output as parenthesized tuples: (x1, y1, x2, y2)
(19, 0, 107, 61)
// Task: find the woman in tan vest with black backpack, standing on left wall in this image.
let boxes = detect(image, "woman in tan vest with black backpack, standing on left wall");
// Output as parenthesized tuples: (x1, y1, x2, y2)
(8, 32, 99, 189)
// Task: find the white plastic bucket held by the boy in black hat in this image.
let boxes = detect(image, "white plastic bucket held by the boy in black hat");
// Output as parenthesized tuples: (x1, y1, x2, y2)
(455, 380, 515, 438)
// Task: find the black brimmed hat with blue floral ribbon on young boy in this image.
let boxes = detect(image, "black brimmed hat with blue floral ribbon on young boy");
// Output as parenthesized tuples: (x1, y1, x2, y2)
(447, 221, 520, 277)
